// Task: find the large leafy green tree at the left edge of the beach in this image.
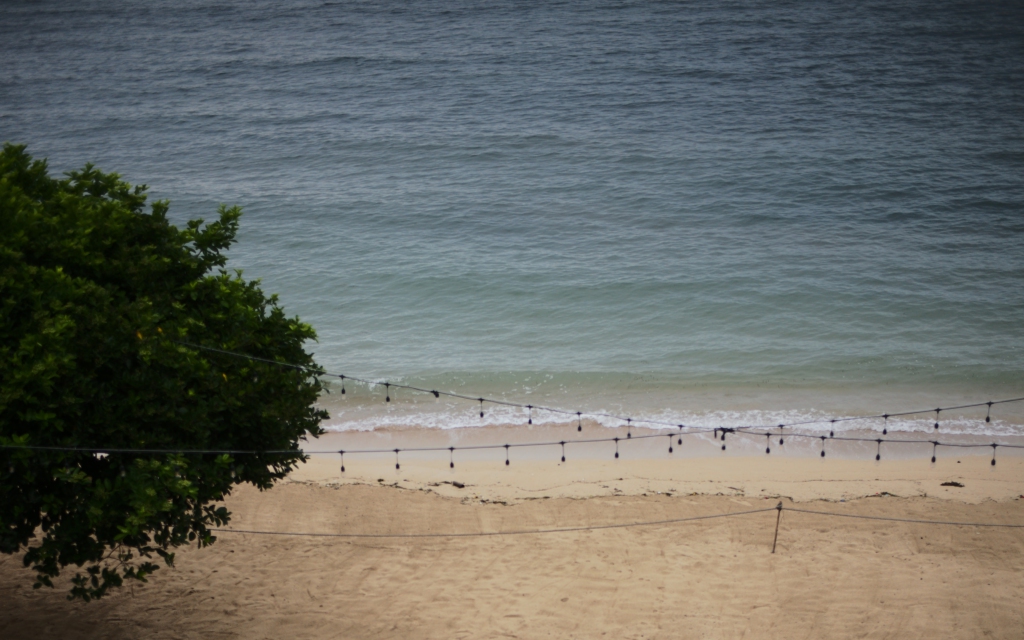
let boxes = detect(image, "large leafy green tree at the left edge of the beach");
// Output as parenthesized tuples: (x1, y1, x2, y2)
(0, 144, 327, 600)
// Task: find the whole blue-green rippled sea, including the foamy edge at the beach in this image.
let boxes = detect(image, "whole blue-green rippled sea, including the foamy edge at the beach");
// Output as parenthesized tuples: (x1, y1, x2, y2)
(0, 0, 1024, 432)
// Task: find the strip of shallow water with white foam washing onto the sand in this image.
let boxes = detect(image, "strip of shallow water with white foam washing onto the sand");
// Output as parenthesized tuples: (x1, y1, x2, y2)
(317, 380, 1024, 434)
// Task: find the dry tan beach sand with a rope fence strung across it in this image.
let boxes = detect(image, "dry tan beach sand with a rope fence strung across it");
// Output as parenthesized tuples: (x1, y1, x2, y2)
(0, 453, 1024, 640)
